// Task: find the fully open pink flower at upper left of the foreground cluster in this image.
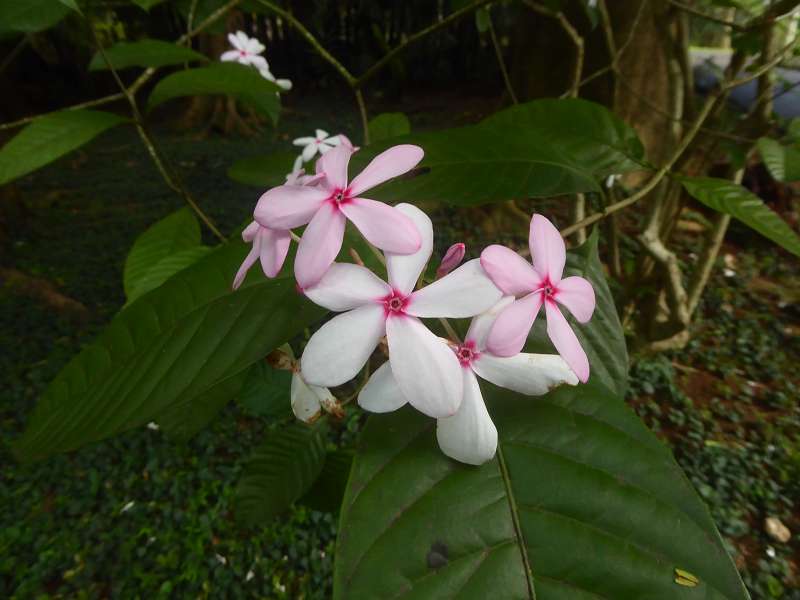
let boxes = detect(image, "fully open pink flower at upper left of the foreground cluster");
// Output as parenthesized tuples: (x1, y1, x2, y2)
(254, 144, 423, 289)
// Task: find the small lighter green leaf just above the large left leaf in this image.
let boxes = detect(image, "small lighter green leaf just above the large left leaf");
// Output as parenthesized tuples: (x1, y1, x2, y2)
(122, 208, 200, 302)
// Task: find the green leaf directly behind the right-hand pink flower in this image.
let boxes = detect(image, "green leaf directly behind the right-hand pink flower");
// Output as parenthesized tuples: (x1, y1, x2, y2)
(525, 228, 629, 397)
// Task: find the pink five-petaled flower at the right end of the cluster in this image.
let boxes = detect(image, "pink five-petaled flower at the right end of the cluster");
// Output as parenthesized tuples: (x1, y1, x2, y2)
(481, 215, 595, 383)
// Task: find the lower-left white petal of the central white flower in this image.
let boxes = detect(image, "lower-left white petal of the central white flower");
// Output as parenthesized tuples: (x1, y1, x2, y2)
(300, 304, 386, 387)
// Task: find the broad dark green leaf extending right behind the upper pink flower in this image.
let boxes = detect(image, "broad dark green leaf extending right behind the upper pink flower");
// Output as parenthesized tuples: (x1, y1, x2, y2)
(350, 100, 643, 205)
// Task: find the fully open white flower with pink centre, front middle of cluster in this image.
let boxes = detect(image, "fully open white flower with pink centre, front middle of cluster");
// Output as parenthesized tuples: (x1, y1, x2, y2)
(300, 204, 501, 417)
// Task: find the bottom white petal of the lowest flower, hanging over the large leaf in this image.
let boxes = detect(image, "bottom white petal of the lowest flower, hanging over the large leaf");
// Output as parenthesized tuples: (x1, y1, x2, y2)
(436, 369, 497, 465)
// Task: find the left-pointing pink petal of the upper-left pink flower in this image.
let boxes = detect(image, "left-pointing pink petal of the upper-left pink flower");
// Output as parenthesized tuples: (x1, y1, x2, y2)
(253, 185, 330, 229)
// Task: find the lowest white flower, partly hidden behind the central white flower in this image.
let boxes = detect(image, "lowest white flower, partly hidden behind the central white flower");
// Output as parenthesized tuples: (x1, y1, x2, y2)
(358, 296, 578, 465)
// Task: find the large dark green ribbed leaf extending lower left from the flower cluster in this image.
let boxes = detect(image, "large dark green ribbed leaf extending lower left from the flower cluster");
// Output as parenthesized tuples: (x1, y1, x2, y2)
(14, 240, 325, 461)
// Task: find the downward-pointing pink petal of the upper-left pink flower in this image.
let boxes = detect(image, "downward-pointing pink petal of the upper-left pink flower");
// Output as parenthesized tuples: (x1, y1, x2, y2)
(294, 202, 347, 289)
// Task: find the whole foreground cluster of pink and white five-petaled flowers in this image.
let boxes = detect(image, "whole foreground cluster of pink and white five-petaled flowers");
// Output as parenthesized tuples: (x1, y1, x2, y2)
(234, 141, 595, 464)
